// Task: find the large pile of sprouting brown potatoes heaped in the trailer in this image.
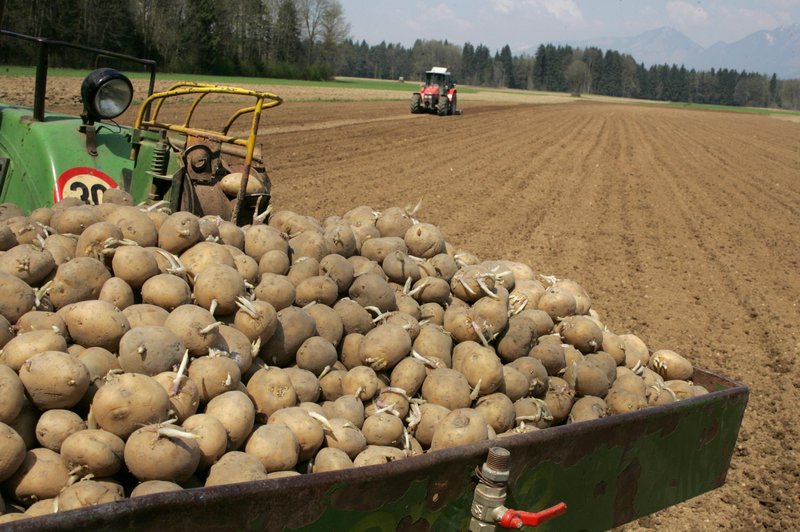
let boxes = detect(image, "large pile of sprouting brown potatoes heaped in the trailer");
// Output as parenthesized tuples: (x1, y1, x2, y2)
(0, 194, 707, 522)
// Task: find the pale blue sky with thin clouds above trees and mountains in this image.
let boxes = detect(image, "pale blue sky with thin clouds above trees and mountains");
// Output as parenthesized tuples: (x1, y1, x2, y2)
(339, 0, 800, 52)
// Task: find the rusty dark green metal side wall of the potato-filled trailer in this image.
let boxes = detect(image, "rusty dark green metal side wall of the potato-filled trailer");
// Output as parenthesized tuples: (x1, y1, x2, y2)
(14, 370, 748, 532)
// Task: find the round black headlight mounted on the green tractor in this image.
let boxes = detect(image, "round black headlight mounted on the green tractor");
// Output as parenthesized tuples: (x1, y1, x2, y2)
(81, 68, 133, 120)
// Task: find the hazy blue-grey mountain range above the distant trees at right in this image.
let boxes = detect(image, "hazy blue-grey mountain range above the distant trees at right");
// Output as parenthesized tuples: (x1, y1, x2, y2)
(523, 24, 800, 79)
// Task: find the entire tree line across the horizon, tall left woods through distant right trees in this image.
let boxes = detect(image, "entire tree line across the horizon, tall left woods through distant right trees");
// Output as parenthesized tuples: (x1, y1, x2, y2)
(0, 0, 800, 109)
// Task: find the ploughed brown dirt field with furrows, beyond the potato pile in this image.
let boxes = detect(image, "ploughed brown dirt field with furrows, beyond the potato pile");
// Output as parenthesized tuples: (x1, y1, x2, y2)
(6, 78, 800, 531)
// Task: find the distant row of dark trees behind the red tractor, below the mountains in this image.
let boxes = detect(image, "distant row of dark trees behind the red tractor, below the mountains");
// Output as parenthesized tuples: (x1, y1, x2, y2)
(336, 39, 800, 109)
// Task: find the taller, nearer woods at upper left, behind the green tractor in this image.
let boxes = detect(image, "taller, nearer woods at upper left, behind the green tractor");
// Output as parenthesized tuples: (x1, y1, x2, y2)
(0, 0, 349, 79)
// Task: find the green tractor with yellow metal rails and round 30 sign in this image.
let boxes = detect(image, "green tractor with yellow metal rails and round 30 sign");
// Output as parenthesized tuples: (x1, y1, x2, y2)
(0, 30, 282, 225)
